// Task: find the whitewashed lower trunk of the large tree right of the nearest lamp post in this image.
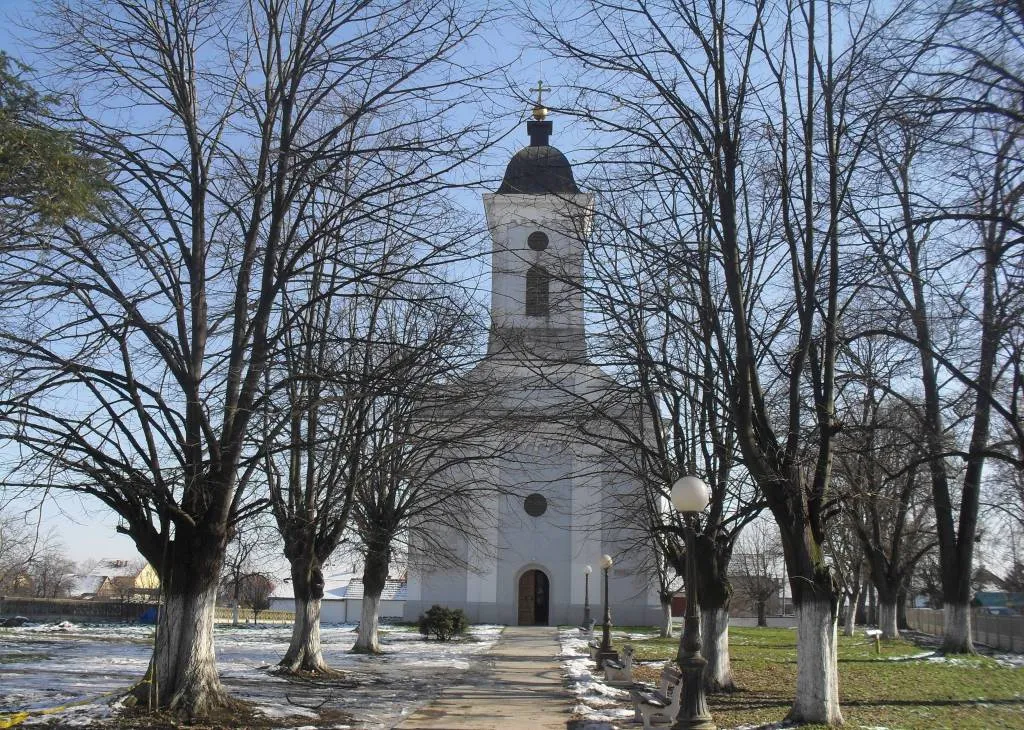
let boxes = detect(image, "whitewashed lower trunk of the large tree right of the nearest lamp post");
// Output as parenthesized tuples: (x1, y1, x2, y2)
(786, 598, 843, 725)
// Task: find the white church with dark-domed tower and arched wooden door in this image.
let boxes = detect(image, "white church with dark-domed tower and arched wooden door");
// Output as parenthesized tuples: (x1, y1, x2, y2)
(404, 104, 660, 626)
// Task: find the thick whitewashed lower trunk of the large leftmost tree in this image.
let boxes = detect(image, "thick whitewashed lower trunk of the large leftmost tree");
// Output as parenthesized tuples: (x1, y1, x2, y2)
(146, 579, 231, 718)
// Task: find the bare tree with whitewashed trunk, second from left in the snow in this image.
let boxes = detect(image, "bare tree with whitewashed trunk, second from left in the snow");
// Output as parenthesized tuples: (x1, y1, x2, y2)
(261, 159, 489, 674)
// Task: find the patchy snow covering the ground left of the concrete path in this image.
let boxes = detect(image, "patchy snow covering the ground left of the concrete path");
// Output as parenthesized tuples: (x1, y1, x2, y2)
(0, 621, 502, 730)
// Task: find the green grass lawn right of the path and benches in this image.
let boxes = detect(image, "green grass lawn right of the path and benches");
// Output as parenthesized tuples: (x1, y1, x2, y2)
(615, 628, 1024, 730)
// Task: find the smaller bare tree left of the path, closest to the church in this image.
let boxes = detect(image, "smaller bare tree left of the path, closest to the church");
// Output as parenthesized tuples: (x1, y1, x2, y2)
(348, 287, 506, 653)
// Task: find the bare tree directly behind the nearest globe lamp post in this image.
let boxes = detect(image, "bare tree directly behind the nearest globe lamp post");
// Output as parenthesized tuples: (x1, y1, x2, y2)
(573, 213, 764, 691)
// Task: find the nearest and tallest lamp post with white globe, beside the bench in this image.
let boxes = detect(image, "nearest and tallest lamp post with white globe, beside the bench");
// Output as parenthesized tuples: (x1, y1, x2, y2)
(672, 476, 716, 730)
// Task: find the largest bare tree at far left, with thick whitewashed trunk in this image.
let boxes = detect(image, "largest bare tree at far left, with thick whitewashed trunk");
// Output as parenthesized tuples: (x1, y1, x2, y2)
(0, 0, 491, 717)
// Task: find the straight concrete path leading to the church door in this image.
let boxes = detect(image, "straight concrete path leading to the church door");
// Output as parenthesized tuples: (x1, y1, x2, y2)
(396, 627, 572, 730)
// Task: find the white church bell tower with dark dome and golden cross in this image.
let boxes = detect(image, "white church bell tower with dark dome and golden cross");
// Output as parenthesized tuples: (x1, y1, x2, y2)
(483, 95, 593, 362)
